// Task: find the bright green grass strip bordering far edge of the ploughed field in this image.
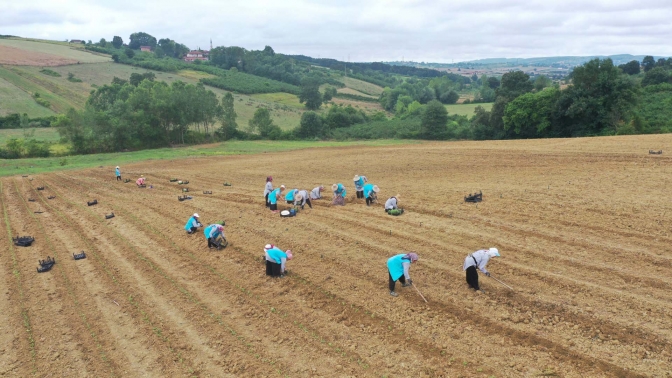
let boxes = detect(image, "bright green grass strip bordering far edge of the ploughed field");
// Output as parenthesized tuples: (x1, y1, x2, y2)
(0, 140, 418, 176)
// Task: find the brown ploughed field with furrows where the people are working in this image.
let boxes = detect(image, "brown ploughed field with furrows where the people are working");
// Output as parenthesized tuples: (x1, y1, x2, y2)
(0, 135, 672, 377)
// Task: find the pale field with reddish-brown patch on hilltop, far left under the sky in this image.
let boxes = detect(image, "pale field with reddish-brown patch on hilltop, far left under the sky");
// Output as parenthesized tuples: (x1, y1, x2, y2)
(0, 39, 111, 66)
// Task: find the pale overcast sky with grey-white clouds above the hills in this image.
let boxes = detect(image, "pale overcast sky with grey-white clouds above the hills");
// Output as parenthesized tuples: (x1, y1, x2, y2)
(0, 0, 672, 63)
